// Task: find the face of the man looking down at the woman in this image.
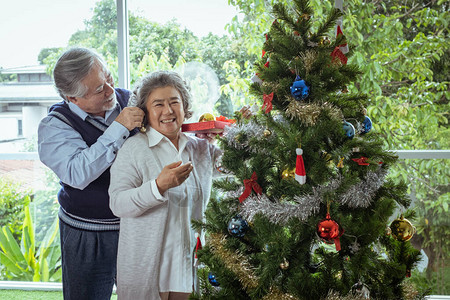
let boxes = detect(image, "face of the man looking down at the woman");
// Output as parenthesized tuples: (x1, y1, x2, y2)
(68, 64, 117, 117)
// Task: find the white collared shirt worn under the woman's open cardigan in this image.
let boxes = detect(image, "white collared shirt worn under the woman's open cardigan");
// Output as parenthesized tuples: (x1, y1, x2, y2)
(148, 128, 202, 292)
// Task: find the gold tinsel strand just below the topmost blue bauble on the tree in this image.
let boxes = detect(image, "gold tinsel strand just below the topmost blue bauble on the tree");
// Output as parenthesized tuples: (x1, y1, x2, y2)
(286, 98, 343, 126)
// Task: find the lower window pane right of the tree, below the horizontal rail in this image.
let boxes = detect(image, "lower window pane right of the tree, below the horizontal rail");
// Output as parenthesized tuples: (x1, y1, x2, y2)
(389, 159, 450, 295)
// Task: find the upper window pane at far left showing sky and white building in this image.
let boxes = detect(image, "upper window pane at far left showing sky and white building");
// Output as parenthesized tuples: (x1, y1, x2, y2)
(0, 0, 104, 152)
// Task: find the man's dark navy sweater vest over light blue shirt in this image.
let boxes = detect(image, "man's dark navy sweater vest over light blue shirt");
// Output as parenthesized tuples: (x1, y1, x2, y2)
(50, 88, 136, 222)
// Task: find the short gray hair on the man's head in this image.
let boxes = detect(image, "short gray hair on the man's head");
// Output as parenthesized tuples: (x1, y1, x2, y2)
(53, 48, 107, 102)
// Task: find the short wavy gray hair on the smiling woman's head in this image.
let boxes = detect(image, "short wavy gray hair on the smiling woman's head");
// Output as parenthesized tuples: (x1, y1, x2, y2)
(133, 71, 192, 125)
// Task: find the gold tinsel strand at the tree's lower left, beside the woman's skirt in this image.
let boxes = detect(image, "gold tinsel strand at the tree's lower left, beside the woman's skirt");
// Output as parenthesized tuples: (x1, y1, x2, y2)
(208, 234, 258, 289)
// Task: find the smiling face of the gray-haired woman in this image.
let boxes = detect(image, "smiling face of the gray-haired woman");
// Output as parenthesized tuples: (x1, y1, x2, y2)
(146, 86, 184, 141)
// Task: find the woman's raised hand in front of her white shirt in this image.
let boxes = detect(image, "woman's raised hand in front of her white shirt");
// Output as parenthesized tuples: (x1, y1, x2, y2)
(156, 161, 193, 195)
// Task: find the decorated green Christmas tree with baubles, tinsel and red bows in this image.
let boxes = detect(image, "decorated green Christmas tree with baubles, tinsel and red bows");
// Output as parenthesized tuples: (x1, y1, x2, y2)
(194, 0, 419, 299)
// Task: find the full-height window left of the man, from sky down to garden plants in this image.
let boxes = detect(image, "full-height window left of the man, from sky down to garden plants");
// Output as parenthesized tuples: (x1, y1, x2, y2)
(0, 0, 111, 284)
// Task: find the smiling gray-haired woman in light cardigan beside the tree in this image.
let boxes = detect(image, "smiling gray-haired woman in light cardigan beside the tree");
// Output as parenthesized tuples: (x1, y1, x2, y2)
(109, 71, 221, 300)
